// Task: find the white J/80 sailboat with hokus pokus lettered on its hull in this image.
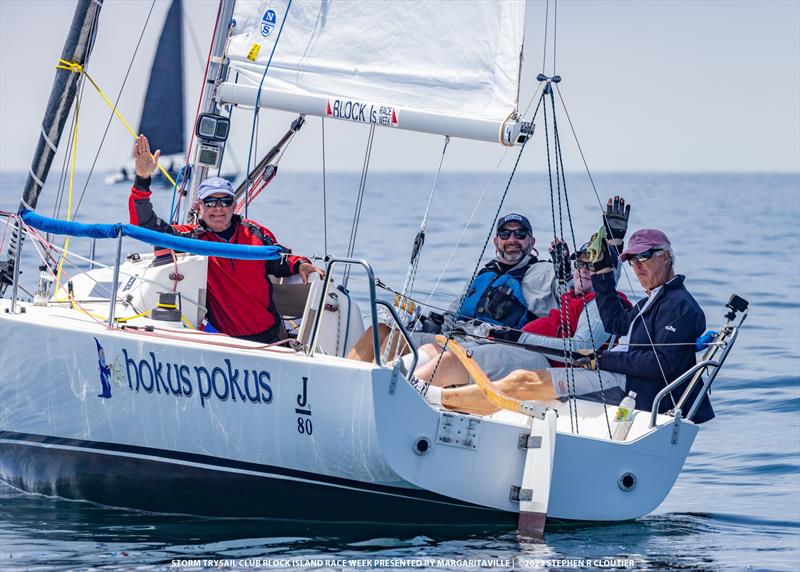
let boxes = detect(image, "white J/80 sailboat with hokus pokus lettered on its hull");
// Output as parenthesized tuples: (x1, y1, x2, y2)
(0, 0, 747, 536)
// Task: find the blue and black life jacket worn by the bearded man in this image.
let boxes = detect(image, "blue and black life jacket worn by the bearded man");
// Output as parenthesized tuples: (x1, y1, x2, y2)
(459, 256, 539, 328)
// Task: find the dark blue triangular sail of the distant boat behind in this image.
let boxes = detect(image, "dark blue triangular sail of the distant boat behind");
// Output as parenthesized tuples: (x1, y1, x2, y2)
(139, 0, 184, 155)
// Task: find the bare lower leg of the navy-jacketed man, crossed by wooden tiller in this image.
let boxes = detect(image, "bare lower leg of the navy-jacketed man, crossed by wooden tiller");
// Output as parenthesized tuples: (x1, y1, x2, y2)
(437, 369, 556, 415)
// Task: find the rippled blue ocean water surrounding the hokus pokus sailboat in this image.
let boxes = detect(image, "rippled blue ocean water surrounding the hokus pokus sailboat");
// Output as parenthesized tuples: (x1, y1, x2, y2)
(0, 169, 800, 571)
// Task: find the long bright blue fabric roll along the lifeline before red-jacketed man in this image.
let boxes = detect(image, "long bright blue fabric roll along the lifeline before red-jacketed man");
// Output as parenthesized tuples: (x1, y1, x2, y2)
(20, 209, 284, 260)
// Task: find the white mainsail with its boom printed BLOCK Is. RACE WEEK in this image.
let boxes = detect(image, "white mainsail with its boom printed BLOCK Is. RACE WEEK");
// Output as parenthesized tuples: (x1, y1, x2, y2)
(218, 0, 525, 143)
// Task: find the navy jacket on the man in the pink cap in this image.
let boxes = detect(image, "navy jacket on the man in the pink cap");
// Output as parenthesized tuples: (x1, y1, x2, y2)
(592, 273, 714, 423)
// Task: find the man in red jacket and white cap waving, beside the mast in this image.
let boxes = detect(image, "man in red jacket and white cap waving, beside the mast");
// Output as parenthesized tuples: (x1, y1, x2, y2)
(128, 135, 325, 343)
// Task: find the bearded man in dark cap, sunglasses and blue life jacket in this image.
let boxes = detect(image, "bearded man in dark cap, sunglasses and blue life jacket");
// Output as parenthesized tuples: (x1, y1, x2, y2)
(348, 213, 558, 365)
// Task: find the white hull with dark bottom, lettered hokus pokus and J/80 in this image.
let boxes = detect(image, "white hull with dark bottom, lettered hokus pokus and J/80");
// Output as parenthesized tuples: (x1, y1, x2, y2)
(0, 294, 697, 524)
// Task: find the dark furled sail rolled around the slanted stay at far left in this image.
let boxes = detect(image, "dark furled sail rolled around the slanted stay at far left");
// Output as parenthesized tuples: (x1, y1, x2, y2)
(0, 0, 103, 295)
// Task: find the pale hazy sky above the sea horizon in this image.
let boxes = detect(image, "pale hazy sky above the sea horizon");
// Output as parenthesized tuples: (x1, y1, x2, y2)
(0, 0, 800, 173)
